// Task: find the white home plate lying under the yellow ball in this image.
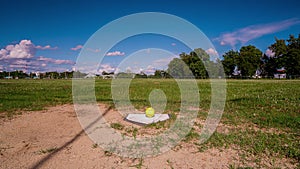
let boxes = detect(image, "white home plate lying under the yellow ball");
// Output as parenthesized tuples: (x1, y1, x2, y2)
(125, 114, 170, 124)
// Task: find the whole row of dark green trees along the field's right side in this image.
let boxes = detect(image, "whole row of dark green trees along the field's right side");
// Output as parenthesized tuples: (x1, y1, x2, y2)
(167, 34, 300, 78)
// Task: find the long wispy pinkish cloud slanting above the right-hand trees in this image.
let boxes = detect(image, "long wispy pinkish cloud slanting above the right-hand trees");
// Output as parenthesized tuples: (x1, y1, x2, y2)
(215, 18, 300, 48)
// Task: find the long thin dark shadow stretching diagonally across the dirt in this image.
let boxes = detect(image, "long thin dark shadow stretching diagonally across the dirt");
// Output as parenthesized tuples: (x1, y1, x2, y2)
(30, 106, 112, 169)
